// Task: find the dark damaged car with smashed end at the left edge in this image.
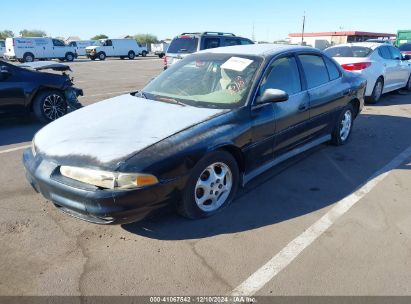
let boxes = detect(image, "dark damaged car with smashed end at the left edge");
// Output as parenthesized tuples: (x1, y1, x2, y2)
(0, 60, 83, 123)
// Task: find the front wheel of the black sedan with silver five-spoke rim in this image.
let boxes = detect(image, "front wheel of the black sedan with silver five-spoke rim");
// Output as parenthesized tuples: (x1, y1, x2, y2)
(178, 151, 239, 219)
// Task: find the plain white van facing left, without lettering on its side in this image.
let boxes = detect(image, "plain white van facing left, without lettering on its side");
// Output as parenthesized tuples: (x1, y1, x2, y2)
(86, 39, 148, 60)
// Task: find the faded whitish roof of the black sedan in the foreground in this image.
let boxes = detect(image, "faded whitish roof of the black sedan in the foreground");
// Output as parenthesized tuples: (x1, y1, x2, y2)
(198, 44, 320, 57)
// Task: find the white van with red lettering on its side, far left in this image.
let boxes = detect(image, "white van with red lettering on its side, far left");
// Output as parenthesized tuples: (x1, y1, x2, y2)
(4, 37, 77, 62)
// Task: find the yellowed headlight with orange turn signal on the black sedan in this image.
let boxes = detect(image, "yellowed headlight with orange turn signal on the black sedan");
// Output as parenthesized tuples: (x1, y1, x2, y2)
(60, 166, 158, 189)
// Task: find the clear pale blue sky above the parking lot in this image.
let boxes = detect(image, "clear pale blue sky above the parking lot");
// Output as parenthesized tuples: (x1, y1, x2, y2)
(0, 0, 411, 42)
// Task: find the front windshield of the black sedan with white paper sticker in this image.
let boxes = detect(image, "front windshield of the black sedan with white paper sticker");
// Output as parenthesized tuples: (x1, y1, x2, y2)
(143, 54, 262, 109)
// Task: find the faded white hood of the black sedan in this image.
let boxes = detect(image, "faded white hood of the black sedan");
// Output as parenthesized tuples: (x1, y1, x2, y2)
(34, 95, 227, 169)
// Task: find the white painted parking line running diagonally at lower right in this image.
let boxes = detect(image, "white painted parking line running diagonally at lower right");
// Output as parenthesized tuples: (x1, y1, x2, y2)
(231, 146, 411, 296)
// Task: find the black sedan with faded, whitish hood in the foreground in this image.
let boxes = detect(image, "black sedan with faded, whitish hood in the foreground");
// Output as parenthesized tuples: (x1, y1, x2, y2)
(23, 45, 366, 224)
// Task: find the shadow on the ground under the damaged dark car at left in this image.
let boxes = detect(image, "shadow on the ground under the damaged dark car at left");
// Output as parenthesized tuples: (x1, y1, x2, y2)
(0, 115, 45, 146)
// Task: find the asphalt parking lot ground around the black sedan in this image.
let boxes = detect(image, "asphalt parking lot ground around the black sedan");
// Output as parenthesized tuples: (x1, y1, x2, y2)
(0, 57, 411, 295)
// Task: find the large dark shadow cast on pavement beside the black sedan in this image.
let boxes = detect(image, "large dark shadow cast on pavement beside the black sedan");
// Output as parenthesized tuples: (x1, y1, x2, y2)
(122, 114, 411, 240)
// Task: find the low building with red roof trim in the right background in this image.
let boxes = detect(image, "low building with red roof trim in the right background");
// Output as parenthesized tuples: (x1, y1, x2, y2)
(288, 31, 395, 49)
